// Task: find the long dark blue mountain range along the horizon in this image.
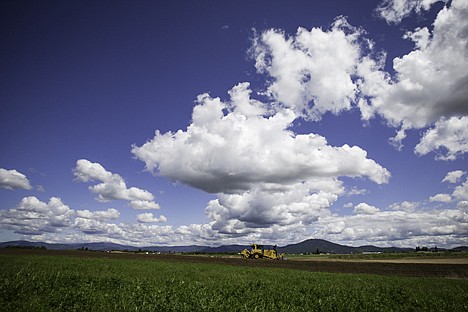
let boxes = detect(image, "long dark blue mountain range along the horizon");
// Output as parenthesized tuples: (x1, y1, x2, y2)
(0, 239, 460, 254)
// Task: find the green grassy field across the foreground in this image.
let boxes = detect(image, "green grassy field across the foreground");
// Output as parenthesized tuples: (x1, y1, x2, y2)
(0, 253, 468, 311)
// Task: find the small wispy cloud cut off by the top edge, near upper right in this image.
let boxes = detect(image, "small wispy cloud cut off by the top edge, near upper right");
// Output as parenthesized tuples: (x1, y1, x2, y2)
(377, 0, 446, 24)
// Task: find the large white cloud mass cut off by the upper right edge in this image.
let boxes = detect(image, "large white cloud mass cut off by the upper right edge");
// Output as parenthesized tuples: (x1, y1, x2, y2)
(366, 0, 468, 154)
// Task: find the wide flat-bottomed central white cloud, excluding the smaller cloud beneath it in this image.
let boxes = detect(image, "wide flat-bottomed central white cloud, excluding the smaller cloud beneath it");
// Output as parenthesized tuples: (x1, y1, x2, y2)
(132, 83, 390, 193)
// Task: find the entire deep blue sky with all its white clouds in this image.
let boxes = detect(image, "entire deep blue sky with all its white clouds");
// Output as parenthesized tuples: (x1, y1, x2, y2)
(0, 0, 468, 248)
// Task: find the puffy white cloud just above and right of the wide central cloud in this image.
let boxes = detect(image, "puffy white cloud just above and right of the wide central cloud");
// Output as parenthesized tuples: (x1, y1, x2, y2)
(252, 17, 361, 120)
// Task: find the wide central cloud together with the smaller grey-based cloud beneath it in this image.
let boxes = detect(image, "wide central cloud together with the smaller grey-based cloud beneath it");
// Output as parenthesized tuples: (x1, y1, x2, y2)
(132, 83, 390, 233)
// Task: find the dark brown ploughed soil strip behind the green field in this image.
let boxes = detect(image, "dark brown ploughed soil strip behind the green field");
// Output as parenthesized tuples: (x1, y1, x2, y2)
(0, 249, 468, 279)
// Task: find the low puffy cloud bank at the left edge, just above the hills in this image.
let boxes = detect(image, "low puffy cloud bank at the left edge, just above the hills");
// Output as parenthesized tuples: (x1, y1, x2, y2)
(0, 196, 74, 235)
